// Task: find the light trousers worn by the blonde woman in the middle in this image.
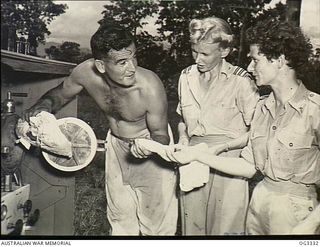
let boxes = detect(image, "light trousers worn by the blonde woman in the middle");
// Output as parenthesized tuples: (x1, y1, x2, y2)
(180, 136, 249, 236)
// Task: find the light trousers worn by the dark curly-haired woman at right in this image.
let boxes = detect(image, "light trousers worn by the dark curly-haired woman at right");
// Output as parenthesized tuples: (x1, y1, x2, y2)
(246, 178, 319, 235)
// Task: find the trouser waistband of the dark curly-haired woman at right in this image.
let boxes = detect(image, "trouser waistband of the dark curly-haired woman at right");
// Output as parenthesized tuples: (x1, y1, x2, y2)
(262, 177, 317, 197)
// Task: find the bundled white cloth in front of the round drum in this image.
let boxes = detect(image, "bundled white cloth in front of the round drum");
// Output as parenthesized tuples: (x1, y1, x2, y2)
(16, 111, 72, 158)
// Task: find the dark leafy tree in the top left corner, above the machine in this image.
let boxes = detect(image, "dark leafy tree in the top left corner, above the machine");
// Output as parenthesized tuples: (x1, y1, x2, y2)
(1, 0, 67, 55)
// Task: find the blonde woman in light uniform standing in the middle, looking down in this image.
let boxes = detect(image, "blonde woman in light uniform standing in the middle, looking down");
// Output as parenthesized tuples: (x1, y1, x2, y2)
(177, 17, 259, 235)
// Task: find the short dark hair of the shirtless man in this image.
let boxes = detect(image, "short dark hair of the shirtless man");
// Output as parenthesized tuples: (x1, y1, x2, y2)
(90, 23, 134, 59)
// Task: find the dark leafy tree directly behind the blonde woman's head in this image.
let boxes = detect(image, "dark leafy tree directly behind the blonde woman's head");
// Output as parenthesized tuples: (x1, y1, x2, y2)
(156, 0, 271, 68)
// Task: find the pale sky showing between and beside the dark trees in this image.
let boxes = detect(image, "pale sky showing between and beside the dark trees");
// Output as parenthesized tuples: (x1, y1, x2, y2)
(47, 0, 320, 48)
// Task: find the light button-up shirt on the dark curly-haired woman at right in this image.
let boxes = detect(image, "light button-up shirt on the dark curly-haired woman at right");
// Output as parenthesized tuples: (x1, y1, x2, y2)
(241, 83, 320, 184)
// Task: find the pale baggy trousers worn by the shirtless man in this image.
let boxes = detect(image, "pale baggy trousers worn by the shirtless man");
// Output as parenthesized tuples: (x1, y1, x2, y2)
(106, 129, 178, 236)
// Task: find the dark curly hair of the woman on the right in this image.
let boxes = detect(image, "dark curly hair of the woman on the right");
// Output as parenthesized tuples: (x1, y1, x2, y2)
(246, 18, 312, 74)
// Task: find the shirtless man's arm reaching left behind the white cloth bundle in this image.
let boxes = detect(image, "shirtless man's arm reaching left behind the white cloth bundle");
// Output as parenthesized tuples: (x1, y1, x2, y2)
(23, 68, 83, 121)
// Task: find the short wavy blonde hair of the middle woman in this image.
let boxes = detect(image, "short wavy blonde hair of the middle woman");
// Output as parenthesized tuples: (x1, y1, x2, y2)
(189, 16, 233, 48)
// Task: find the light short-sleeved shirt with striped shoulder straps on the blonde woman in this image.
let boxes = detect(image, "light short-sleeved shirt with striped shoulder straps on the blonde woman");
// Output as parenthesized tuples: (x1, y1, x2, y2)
(177, 60, 259, 138)
